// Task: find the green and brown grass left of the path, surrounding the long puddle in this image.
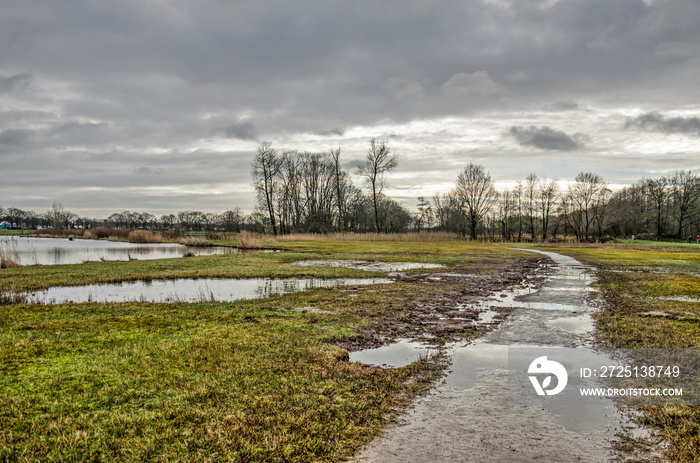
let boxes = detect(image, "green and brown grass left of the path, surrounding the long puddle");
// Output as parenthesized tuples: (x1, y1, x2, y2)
(0, 242, 527, 461)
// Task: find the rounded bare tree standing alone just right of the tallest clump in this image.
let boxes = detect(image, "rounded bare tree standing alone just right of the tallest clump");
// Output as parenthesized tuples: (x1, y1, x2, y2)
(455, 163, 498, 239)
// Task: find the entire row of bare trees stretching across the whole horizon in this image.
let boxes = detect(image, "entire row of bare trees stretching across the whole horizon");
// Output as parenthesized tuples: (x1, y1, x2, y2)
(0, 140, 700, 241)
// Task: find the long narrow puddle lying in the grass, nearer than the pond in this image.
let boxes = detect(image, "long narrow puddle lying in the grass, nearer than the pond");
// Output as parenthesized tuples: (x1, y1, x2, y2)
(27, 278, 392, 304)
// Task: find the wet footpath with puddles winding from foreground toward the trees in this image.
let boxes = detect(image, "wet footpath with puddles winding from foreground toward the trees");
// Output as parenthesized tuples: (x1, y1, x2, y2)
(356, 252, 648, 462)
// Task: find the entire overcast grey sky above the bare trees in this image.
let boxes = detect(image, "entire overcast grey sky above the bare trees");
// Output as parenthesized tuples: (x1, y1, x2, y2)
(0, 0, 700, 217)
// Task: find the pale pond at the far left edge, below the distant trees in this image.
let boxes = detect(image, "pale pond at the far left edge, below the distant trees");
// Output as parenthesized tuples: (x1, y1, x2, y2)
(0, 236, 241, 265)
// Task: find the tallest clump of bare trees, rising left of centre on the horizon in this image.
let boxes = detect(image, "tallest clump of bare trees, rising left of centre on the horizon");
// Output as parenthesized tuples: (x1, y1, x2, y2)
(252, 139, 413, 234)
